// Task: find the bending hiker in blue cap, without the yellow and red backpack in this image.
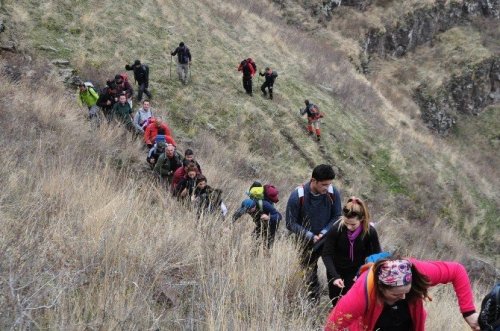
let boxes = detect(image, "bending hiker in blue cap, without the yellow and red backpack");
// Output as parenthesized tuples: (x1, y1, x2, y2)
(233, 199, 282, 249)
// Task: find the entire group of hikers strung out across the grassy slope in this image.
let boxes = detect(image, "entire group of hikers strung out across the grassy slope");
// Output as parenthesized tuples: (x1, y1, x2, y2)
(78, 43, 500, 331)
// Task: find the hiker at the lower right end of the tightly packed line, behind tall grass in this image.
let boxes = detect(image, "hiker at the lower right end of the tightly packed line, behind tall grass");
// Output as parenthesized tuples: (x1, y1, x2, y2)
(194, 175, 227, 219)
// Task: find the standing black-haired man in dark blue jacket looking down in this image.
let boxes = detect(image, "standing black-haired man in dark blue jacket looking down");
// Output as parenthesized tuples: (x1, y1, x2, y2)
(286, 164, 342, 303)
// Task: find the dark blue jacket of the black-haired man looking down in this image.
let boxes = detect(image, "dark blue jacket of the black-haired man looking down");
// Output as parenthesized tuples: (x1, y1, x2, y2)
(286, 182, 342, 241)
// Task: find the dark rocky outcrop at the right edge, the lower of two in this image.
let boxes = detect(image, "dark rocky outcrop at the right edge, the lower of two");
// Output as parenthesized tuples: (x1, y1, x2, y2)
(415, 56, 500, 135)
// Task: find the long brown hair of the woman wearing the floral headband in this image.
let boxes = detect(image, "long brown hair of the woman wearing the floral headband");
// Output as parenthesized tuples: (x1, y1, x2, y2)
(373, 256, 431, 302)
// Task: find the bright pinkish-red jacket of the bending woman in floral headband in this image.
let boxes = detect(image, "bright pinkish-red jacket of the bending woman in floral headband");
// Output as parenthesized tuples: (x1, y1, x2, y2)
(325, 259, 476, 331)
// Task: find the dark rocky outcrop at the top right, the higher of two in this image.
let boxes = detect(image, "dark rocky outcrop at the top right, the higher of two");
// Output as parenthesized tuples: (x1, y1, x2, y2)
(362, 0, 500, 58)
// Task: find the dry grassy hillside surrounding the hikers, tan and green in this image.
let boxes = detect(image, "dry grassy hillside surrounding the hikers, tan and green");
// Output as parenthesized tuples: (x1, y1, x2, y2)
(0, 0, 500, 330)
